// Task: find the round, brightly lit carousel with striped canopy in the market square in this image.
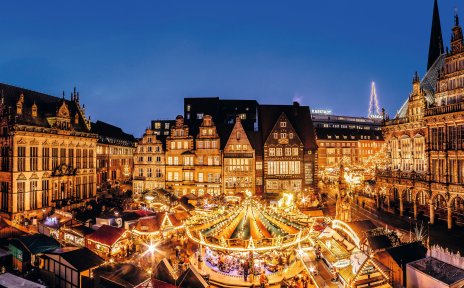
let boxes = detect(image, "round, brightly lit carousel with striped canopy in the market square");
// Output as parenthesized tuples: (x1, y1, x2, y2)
(185, 198, 310, 282)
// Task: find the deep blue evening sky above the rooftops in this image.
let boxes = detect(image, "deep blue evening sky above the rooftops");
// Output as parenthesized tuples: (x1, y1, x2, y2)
(0, 0, 464, 136)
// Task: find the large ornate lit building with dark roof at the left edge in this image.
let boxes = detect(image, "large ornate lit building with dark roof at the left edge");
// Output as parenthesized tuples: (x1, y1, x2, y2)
(0, 84, 98, 218)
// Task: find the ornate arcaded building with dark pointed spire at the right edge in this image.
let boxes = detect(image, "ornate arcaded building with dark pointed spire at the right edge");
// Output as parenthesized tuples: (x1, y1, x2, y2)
(377, 1, 464, 228)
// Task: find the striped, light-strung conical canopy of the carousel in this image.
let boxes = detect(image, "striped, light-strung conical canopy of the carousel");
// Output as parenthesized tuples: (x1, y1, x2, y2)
(186, 199, 308, 249)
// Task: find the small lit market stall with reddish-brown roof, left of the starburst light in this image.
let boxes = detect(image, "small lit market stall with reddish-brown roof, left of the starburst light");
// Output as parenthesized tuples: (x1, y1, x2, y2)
(85, 225, 132, 260)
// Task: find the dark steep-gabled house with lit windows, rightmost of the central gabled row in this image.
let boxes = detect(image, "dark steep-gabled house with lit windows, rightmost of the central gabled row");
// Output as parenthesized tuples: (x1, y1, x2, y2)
(259, 102, 317, 197)
